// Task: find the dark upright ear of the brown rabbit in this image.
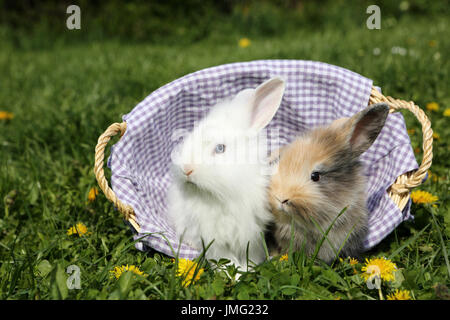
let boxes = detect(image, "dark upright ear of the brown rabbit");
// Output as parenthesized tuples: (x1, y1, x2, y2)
(347, 103, 389, 157)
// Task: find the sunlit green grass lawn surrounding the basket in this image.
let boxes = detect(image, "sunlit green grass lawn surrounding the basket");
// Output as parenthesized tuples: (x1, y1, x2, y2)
(0, 5, 450, 299)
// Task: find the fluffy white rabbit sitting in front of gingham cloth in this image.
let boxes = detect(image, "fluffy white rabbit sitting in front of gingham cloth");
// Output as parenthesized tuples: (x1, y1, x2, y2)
(168, 77, 285, 268)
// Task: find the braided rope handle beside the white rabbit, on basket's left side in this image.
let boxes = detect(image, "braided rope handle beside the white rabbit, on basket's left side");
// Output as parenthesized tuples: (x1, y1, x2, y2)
(94, 122, 140, 232)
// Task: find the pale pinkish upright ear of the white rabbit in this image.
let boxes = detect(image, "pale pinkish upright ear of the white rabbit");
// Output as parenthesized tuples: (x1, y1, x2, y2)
(250, 77, 286, 131)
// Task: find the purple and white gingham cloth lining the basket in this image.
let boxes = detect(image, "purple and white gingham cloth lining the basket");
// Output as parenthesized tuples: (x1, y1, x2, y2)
(108, 60, 418, 259)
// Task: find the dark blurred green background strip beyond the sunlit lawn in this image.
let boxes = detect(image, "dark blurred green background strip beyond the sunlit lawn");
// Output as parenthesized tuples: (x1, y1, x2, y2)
(0, 0, 450, 47)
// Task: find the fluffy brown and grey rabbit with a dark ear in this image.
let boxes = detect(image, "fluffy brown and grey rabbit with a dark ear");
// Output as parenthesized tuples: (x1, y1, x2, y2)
(269, 103, 389, 263)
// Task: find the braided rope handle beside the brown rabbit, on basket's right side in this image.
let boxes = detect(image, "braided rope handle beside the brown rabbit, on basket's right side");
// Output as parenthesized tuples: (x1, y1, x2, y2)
(369, 88, 433, 209)
